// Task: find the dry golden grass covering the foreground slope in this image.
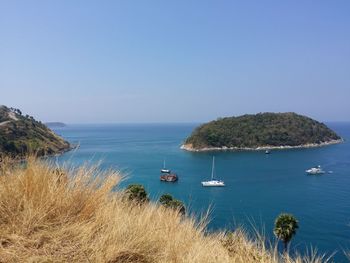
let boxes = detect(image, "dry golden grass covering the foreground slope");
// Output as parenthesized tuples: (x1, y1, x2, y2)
(0, 159, 328, 263)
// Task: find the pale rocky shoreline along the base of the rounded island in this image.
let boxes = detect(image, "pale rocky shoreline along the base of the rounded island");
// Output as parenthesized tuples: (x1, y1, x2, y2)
(180, 138, 344, 152)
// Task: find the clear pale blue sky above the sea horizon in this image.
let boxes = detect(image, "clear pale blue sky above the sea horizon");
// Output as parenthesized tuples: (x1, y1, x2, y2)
(0, 0, 350, 123)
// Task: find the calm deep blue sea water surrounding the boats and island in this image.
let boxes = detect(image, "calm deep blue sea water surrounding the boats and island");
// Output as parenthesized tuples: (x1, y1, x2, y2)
(52, 123, 350, 262)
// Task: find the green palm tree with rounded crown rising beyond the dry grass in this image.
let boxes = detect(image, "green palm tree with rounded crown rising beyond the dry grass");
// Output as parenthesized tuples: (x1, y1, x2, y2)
(273, 214, 299, 251)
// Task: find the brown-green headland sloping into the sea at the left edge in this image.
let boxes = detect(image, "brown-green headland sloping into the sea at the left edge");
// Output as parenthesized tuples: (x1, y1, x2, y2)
(0, 106, 70, 156)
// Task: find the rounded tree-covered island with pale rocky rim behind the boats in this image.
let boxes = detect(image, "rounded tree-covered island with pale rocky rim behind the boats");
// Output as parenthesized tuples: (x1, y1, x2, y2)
(181, 112, 343, 151)
